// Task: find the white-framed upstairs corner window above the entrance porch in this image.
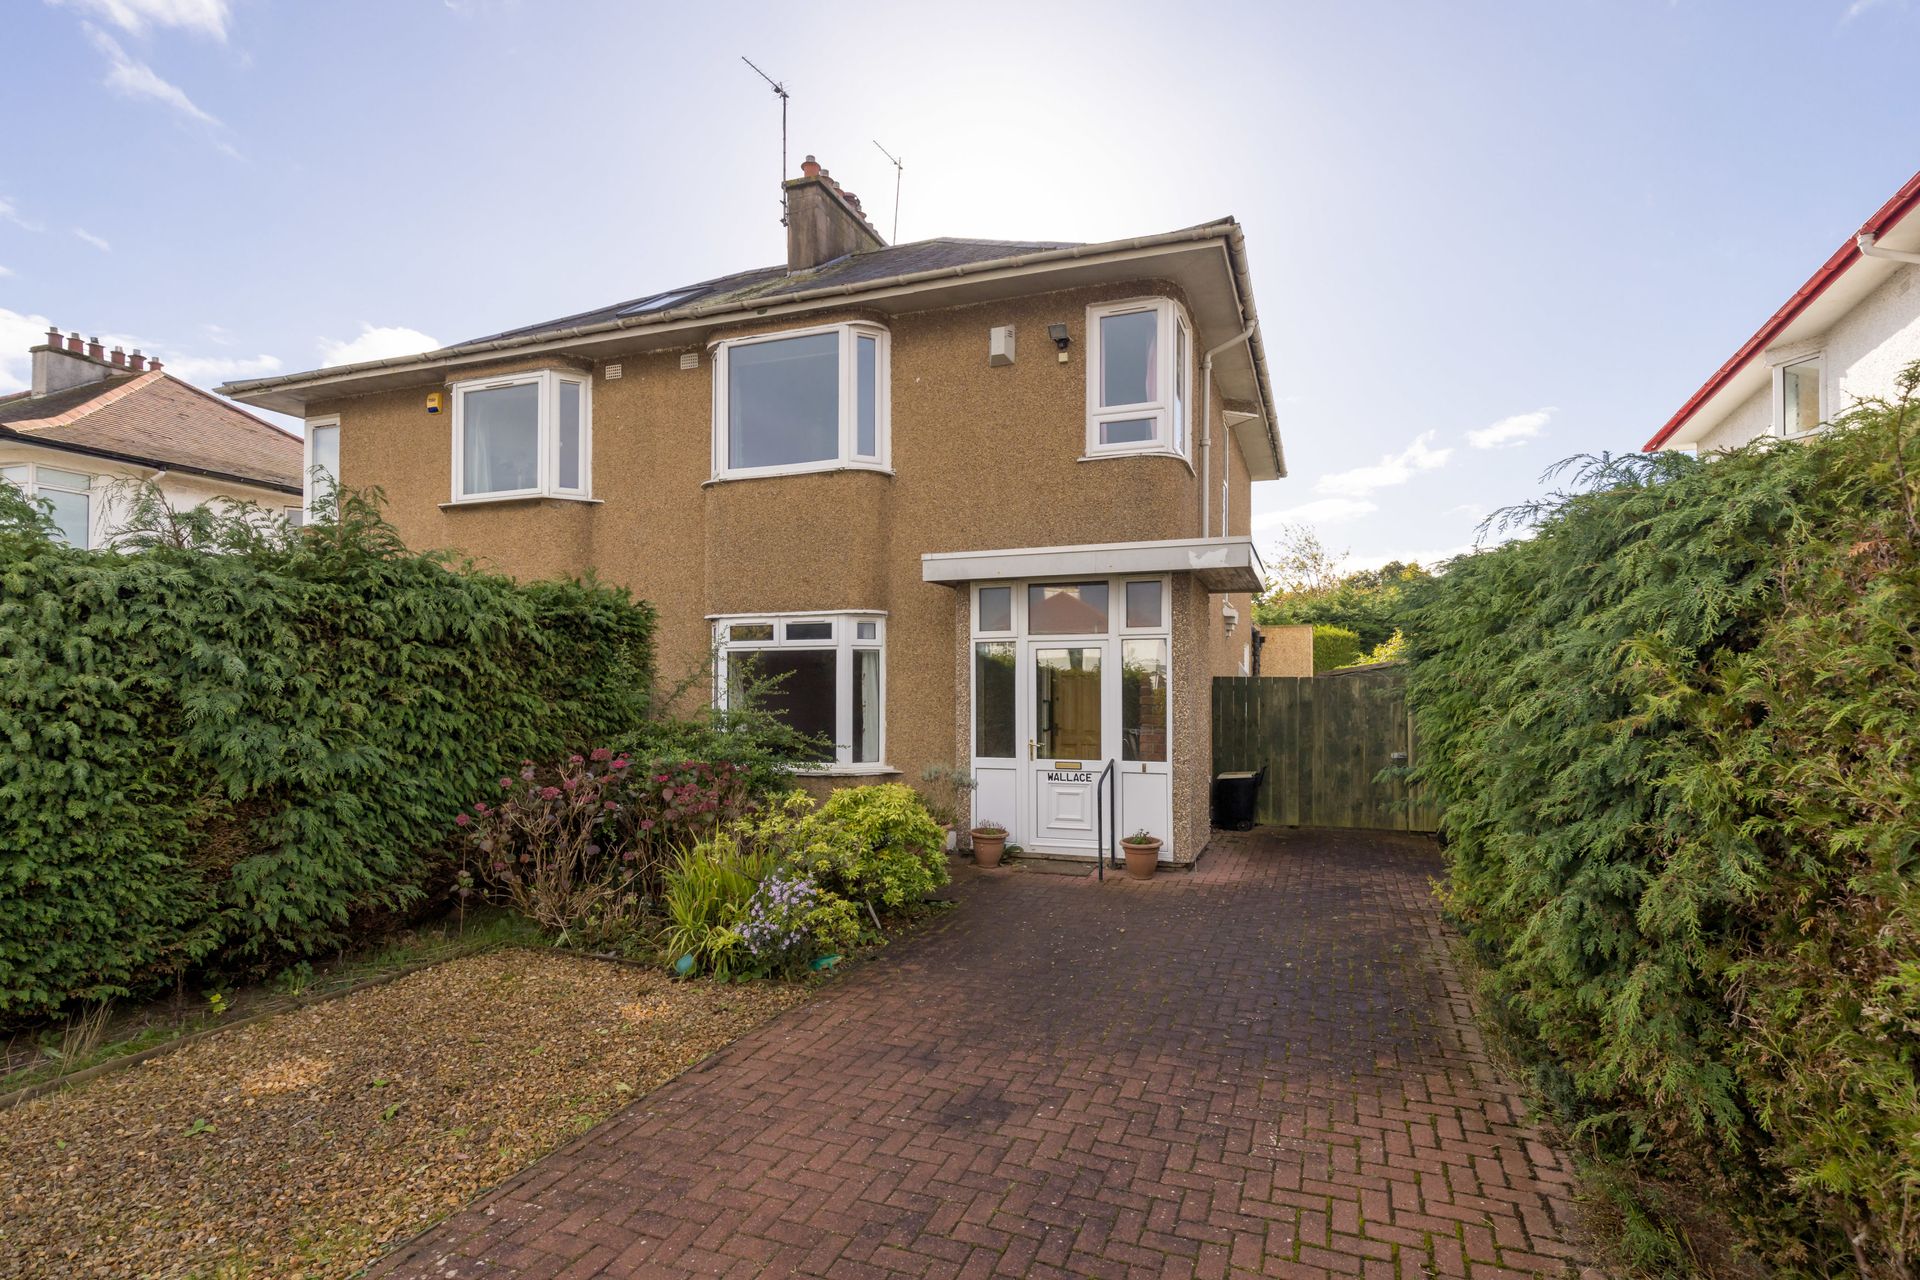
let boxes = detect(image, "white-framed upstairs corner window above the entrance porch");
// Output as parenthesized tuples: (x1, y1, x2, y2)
(1087, 297, 1192, 457)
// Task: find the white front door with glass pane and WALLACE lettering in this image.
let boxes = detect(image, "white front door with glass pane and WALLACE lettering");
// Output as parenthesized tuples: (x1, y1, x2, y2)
(1027, 641, 1112, 852)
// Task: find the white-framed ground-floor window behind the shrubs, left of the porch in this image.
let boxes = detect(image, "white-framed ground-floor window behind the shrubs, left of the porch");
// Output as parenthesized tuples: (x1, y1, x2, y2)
(714, 612, 887, 773)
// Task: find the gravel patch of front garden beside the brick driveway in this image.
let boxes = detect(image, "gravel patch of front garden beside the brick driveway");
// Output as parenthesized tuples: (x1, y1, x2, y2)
(0, 950, 808, 1278)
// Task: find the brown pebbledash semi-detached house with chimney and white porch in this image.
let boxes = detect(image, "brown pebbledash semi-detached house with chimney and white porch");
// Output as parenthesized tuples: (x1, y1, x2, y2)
(223, 157, 1284, 862)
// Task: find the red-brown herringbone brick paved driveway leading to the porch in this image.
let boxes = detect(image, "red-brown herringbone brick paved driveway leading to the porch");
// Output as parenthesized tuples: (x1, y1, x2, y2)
(376, 831, 1580, 1280)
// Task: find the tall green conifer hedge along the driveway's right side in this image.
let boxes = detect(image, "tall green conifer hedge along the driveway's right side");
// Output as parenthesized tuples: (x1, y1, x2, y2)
(1407, 367, 1920, 1276)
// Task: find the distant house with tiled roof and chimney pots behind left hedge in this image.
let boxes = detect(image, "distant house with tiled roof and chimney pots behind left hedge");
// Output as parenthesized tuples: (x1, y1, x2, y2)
(0, 328, 303, 547)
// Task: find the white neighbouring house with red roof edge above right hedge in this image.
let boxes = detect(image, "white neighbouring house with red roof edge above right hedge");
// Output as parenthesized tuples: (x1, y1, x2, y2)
(1645, 173, 1920, 451)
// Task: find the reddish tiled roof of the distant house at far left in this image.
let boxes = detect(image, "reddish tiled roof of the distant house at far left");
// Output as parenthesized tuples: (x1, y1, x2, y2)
(0, 372, 305, 493)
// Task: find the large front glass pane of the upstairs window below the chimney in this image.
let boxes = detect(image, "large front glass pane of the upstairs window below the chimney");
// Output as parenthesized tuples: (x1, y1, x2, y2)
(728, 334, 839, 466)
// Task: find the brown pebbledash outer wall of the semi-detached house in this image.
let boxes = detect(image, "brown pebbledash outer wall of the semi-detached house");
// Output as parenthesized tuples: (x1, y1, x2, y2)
(307, 280, 1252, 862)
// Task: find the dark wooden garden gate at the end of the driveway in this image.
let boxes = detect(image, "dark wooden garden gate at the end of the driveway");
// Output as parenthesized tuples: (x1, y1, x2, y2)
(1213, 662, 1440, 831)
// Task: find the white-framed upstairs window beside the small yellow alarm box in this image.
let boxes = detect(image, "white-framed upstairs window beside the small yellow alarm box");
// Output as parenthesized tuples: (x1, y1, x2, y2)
(453, 368, 593, 503)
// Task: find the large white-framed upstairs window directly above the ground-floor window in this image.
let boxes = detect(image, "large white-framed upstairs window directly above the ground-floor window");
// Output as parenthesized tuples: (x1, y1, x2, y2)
(714, 324, 889, 480)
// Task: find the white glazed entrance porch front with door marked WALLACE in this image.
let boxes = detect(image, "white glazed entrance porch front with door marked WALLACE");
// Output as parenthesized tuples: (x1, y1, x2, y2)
(970, 576, 1175, 858)
